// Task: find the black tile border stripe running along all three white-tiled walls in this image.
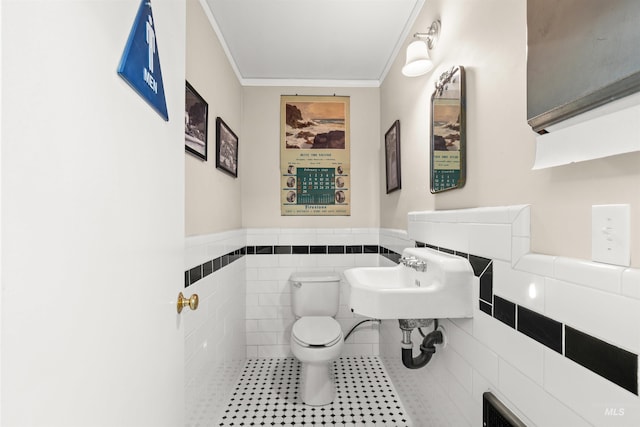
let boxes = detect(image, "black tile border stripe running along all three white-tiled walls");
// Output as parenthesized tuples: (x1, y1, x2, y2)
(184, 242, 638, 396)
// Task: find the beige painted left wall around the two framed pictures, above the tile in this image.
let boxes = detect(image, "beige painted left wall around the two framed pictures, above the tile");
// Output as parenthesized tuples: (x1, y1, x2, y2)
(185, 0, 244, 236)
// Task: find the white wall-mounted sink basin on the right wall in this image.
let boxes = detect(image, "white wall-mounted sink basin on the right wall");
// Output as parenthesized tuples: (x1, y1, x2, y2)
(344, 248, 476, 319)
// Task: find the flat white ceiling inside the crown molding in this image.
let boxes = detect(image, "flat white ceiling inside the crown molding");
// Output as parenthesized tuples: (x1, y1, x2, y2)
(201, 0, 424, 86)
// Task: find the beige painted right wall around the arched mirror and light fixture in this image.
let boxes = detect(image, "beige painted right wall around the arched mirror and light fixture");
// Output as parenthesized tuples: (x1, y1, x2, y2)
(380, 0, 640, 267)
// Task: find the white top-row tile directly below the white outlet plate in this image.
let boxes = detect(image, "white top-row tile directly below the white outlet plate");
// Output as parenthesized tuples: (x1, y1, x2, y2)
(554, 257, 625, 294)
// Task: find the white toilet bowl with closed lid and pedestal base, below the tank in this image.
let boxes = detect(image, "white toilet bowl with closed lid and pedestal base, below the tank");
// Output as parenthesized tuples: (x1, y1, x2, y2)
(291, 316, 344, 406)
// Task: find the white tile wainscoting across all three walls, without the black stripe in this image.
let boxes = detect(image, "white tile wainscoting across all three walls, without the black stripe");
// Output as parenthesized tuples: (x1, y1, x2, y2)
(184, 214, 640, 427)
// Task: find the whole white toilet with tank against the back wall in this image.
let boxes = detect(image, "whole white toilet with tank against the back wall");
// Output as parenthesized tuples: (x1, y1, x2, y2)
(290, 272, 344, 406)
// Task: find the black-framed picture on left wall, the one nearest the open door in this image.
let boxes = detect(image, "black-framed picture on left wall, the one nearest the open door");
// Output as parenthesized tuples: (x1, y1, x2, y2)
(184, 82, 209, 161)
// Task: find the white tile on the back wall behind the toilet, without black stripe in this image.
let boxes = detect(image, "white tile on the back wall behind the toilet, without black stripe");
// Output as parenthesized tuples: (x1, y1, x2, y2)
(245, 228, 379, 358)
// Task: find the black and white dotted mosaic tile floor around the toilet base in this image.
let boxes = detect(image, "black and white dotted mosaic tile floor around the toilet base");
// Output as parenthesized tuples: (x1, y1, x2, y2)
(216, 356, 412, 427)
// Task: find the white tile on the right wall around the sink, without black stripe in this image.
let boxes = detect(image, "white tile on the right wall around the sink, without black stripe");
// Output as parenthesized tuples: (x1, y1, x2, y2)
(380, 206, 640, 427)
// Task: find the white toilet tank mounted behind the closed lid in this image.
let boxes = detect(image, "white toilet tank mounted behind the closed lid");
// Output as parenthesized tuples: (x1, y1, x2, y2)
(289, 271, 340, 317)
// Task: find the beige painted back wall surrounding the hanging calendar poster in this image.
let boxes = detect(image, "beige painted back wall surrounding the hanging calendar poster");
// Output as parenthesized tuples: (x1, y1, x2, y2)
(239, 87, 380, 228)
